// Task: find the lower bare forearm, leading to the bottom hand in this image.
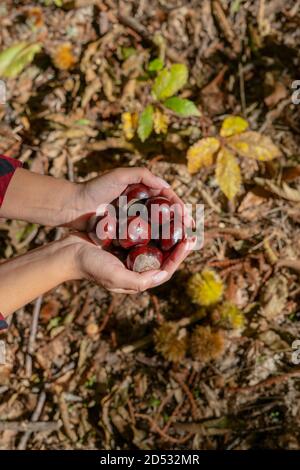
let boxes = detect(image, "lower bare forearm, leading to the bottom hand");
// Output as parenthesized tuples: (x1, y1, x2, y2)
(0, 238, 78, 316)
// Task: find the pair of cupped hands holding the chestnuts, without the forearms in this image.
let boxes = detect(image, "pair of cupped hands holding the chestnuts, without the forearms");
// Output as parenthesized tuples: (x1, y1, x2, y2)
(69, 167, 196, 294)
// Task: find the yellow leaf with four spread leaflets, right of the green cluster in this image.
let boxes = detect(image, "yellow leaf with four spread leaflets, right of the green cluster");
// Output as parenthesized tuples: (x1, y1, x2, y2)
(187, 116, 281, 200)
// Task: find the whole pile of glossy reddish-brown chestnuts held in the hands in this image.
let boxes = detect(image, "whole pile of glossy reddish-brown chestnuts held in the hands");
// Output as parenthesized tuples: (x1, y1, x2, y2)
(88, 183, 184, 272)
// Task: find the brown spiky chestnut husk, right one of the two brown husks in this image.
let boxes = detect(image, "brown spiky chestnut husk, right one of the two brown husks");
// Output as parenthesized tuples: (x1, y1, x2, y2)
(191, 325, 225, 364)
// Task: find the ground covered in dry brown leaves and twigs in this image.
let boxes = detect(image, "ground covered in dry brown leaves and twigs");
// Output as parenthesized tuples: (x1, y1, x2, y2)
(0, 0, 300, 450)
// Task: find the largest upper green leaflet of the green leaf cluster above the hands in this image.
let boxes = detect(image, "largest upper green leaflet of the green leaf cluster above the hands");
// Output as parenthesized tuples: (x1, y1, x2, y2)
(152, 64, 188, 100)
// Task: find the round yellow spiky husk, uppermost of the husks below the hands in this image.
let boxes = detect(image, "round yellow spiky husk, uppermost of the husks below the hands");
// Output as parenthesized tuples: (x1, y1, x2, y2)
(187, 269, 224, 306)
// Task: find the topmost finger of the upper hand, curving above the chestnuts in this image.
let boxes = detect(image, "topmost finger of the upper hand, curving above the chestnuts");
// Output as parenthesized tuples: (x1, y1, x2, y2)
(112, 167, 170, 190)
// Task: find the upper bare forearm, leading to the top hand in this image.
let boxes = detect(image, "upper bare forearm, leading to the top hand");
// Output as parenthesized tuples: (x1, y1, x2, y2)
(0, 168, 85, 229)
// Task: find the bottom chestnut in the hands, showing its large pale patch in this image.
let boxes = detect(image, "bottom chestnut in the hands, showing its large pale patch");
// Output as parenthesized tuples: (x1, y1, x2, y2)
(126, 245, 163, 273)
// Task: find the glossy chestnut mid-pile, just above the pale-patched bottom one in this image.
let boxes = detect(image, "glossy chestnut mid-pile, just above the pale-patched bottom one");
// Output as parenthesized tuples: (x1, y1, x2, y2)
(119, 216, 151, 249)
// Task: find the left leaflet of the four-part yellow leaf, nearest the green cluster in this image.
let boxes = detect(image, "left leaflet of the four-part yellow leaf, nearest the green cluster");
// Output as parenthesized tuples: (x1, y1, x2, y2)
(187, 137, 220, 173)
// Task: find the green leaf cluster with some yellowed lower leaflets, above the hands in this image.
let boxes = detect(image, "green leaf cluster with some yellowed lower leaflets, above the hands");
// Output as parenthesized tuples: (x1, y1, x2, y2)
(122, 58, 200, 142)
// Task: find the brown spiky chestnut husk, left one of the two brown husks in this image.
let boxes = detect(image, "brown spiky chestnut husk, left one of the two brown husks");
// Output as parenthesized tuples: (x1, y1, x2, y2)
(154, 322, 188, 362)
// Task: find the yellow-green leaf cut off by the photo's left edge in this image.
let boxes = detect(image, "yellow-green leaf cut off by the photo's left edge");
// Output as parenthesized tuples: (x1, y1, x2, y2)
(0, 42, 42, 78)
